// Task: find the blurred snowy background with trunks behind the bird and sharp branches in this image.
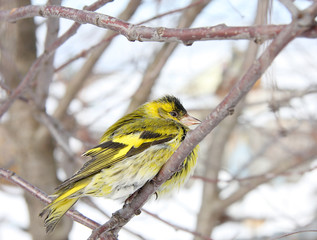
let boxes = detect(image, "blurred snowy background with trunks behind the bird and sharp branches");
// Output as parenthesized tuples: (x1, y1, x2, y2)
(0, 0, 317, 240)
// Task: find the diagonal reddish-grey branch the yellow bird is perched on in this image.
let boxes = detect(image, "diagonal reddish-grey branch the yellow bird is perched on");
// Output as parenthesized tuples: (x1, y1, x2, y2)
(89, 2, 317, 240)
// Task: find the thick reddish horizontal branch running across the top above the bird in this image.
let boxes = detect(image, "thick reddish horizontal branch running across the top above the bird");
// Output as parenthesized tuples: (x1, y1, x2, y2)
(0, 6, 317, 44)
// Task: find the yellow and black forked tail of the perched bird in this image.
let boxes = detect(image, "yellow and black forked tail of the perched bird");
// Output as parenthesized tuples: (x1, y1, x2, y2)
(40, 184, 86, 233)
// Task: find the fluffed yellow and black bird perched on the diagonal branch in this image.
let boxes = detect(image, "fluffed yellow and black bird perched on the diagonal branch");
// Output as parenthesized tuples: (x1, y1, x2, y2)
(40, 95, 200, 232)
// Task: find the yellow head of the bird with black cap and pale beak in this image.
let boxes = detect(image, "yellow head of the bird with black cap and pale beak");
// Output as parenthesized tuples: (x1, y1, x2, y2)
(144, 95, 201, 127)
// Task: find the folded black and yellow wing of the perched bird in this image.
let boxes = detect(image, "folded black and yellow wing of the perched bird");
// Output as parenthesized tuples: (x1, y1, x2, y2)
(57, 119, 181, 190)
